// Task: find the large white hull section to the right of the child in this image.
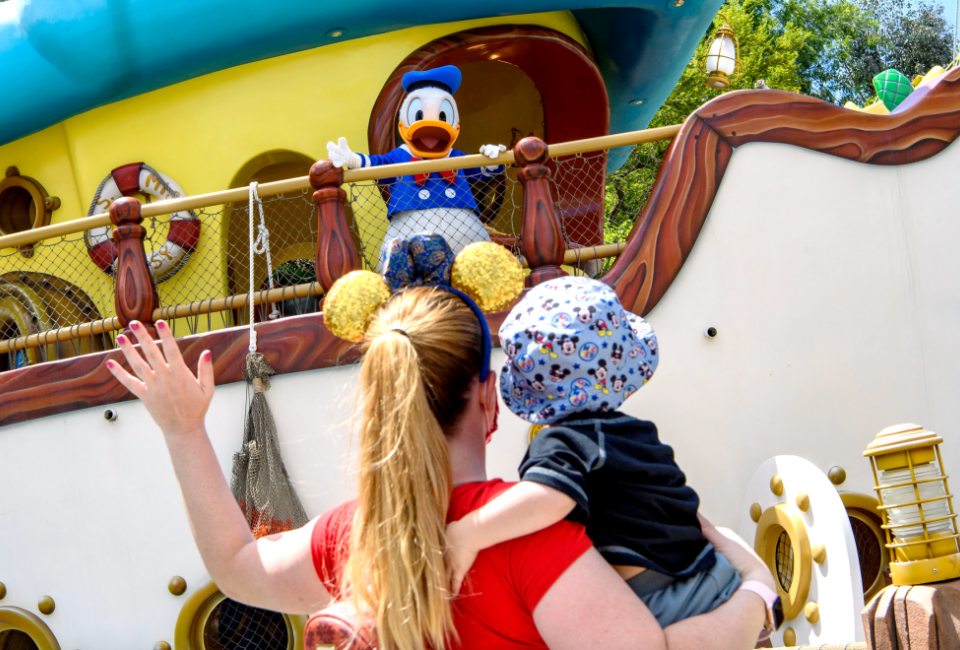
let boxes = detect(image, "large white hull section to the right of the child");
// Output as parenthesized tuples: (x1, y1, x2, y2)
(625, 137, 960, 528)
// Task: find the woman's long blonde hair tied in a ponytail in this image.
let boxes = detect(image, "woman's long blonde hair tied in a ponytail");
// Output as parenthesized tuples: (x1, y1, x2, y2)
(344, 288, 482, 650)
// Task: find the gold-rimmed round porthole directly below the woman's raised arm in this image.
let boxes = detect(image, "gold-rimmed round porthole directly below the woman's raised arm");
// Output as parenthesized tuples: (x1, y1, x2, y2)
(175, 582, 306, 650)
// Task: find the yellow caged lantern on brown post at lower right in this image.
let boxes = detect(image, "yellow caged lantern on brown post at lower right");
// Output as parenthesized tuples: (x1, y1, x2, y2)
(863, 424, 960, 585)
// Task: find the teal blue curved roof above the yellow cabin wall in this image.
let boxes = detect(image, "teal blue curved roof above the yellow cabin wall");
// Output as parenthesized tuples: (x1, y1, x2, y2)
(0, 0, 721, 144)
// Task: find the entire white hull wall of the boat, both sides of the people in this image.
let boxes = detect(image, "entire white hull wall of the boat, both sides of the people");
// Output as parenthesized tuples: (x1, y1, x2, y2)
(0, 135, 960, 650)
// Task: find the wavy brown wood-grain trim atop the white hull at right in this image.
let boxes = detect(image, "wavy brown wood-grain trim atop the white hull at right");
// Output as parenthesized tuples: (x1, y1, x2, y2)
(603, 68, 960, 314)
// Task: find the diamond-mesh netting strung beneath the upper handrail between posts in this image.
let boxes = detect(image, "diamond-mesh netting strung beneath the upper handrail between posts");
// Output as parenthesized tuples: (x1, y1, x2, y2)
(0, 142, 669, 371)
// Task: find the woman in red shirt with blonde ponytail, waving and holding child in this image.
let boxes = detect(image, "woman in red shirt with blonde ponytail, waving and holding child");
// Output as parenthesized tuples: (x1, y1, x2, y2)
(107, 288, 765, 650)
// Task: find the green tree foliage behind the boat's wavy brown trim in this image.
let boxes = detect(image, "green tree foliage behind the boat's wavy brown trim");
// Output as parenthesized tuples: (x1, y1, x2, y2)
(604, 0, 954, 253)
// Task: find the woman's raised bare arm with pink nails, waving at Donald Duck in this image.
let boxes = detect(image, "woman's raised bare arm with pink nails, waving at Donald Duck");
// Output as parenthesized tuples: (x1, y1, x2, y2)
(107, 321, 330, 614)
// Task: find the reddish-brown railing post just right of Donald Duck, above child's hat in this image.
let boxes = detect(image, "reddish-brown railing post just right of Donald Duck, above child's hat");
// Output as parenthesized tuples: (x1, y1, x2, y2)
(513, 138, 567, 287)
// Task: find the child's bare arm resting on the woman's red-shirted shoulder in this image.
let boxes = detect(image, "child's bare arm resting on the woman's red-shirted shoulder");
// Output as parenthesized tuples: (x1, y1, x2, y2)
(447, 481, 577, 594)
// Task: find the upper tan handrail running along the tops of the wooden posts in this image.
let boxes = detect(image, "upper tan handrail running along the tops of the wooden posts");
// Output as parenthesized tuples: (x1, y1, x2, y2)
(0, 124, 680, 249)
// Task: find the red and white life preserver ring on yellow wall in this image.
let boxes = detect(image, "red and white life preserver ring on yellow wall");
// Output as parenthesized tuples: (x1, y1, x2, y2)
(83, 163, 200, 284)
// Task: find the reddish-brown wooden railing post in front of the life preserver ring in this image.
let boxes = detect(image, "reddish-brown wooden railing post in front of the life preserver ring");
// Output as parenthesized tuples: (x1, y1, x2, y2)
(110, 197, 160, 335)
